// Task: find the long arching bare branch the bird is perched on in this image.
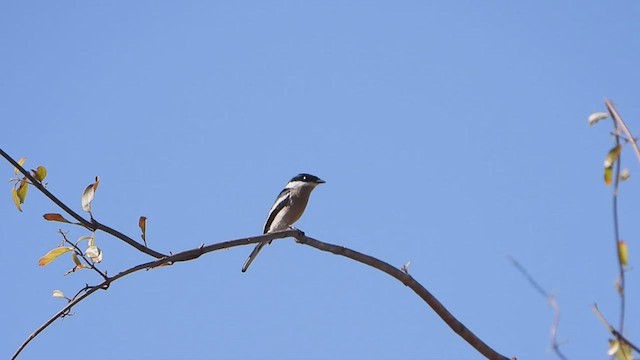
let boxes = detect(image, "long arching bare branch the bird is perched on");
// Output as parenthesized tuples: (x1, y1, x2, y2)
(12, 230, 508, 360)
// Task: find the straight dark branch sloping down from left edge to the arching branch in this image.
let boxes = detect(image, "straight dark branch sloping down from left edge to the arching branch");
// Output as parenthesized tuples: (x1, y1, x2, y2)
(0, 148, 166, 259)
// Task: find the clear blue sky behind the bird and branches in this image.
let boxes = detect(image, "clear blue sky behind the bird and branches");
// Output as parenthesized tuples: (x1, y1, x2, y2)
(0, 1, 640, 360)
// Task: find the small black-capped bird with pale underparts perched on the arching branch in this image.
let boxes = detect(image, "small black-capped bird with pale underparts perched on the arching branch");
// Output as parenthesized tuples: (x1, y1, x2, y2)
(242, 174, 325, 272)
